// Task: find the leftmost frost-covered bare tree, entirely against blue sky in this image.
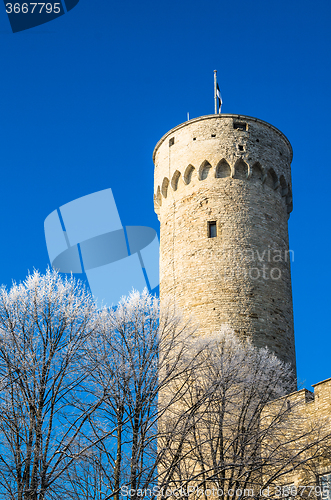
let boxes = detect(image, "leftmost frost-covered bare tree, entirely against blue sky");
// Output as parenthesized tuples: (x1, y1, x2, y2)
(0, 270, 107, 500)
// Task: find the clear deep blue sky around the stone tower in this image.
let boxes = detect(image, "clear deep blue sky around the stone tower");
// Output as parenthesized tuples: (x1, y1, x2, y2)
(0, 0, 331, 387)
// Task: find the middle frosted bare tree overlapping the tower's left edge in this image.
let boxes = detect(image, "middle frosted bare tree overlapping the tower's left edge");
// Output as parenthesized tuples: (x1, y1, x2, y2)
(65, 291, 200, 500)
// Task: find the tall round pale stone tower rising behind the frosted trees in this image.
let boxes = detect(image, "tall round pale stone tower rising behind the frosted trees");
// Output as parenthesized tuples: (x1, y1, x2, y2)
(153, 114, 295, 376)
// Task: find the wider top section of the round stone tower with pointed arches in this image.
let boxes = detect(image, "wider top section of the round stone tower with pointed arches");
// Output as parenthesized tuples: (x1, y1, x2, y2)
(153, 115, 293, 218)
